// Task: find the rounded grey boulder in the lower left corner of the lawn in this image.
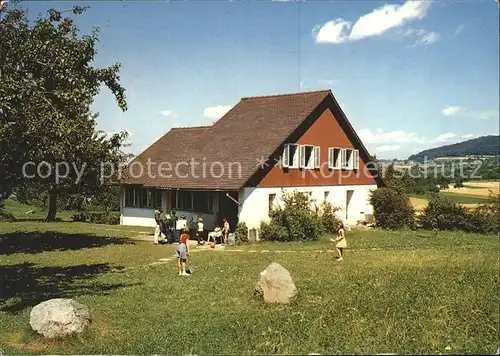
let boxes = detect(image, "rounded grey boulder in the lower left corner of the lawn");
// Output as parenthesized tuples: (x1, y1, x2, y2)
(30, 298, 91, 338)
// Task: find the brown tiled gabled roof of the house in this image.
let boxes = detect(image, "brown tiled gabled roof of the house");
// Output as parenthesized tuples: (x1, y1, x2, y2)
(123, 90, 382, 190)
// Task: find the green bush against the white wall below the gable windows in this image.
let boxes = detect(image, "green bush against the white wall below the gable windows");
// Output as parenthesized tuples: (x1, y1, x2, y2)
(260, 191, 323, 241)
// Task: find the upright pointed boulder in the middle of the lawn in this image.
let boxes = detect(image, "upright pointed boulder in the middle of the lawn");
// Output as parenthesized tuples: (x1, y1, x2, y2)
(255, 262, 297, 304)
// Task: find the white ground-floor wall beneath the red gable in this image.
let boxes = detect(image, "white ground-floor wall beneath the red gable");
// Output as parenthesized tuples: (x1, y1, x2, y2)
(238, 185, 377, 229)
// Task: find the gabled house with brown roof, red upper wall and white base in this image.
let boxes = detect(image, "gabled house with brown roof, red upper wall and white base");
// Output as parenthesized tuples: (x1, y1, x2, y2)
(120, 90, 383, 229)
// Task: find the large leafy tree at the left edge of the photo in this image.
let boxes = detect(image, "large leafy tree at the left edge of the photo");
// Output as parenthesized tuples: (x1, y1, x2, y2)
(0, 4, 127, 221)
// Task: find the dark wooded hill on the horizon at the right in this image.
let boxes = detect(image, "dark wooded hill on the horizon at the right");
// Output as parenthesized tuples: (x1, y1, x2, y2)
(408, 135, 500, 162)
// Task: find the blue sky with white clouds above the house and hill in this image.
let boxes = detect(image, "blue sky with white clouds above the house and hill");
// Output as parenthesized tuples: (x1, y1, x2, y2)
(23, 0, 499, 159)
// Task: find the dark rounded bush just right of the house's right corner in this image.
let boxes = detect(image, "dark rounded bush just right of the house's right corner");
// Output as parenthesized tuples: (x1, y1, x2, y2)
(370, 188, 415, 229)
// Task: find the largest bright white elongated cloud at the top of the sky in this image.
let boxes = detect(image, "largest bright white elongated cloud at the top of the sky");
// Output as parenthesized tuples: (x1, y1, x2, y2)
(313, 0, 432, 44)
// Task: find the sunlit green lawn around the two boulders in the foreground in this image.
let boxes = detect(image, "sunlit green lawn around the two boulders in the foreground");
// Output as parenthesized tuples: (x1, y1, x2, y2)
(0, 222, 500, 355)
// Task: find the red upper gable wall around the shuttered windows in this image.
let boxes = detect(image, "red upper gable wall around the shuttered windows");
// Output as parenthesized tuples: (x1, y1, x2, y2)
(257, 109, 377, 187)
